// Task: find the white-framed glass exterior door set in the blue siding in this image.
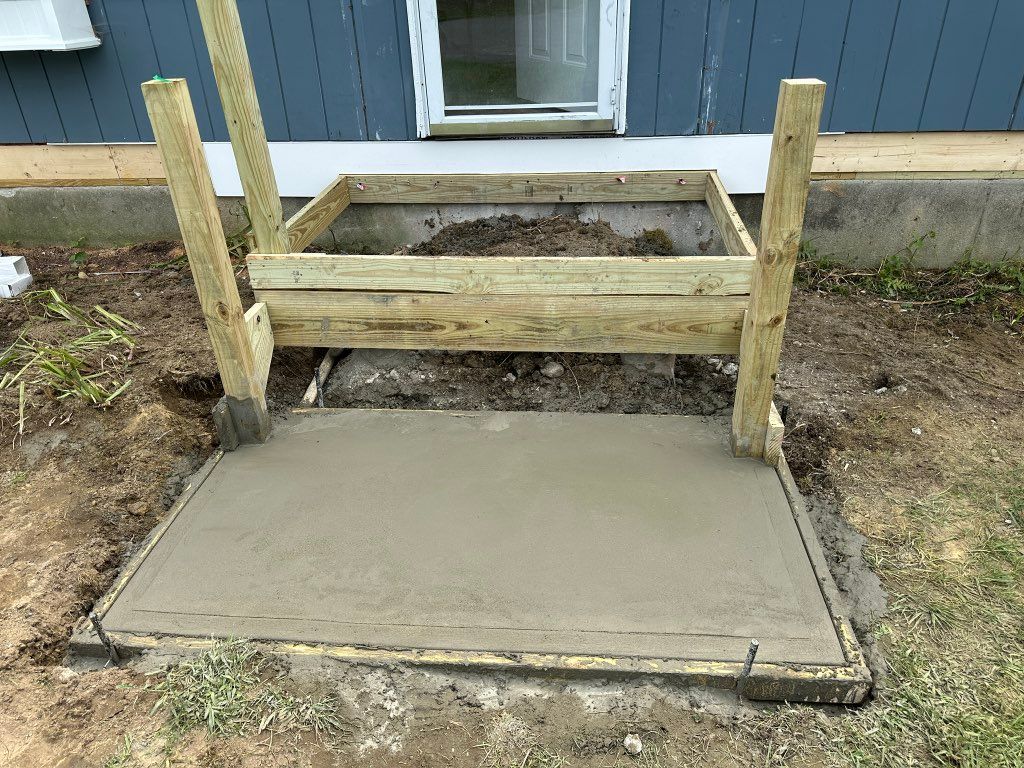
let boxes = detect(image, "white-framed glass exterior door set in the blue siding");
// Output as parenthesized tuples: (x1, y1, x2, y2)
(409, 0, 629, 136)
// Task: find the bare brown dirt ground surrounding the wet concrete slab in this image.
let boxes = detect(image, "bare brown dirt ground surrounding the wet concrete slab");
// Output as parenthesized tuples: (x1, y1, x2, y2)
(0, 219, 1024, 768)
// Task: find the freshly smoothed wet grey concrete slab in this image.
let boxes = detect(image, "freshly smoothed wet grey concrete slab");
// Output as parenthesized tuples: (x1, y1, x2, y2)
(103, 411, 846, 665)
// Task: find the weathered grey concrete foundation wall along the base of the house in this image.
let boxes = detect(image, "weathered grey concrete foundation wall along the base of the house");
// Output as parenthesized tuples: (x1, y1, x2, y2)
(0, 179, 1024, 266)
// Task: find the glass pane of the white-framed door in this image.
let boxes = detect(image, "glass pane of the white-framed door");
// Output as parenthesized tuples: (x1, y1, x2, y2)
(437, 0, 600, 115)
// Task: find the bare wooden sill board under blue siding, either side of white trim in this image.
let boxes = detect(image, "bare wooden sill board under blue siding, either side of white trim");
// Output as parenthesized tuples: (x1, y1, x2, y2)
(0, 131, 1024, 188)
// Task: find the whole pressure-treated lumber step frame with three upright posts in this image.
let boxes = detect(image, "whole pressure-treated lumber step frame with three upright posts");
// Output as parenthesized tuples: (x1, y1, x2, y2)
(142, 0, 824, 464)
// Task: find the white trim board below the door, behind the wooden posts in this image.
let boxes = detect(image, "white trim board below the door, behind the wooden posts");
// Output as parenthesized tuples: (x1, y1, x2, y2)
(204, 134, 771, 198)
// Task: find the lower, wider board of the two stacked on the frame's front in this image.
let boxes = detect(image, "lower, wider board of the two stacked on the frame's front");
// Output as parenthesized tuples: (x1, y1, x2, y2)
(256, 291, 746, 354)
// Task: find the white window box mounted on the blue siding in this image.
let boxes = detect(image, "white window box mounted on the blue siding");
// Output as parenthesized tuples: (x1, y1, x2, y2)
(0, 0, 99, 50)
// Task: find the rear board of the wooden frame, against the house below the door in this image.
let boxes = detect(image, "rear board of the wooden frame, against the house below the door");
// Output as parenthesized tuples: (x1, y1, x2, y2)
(348, 171, 708, 203)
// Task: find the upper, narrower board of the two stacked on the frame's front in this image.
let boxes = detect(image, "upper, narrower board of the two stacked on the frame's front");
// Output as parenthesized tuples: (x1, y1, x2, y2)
(248, 253, 754, 296)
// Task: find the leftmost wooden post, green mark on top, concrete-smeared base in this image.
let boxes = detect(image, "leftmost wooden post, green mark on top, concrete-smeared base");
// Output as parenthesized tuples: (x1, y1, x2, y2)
(142, 80, 270, 442)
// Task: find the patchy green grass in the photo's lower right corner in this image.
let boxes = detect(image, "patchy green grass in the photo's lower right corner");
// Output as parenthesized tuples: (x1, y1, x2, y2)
(757, 465, 1024, 768)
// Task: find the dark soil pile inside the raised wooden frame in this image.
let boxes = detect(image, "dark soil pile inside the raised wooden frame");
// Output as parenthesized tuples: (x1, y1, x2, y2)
(402, 214, 672, 257)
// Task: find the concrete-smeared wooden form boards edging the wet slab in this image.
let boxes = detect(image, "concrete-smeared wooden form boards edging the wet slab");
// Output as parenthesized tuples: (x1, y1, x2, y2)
(69, 434, 871, 705)
